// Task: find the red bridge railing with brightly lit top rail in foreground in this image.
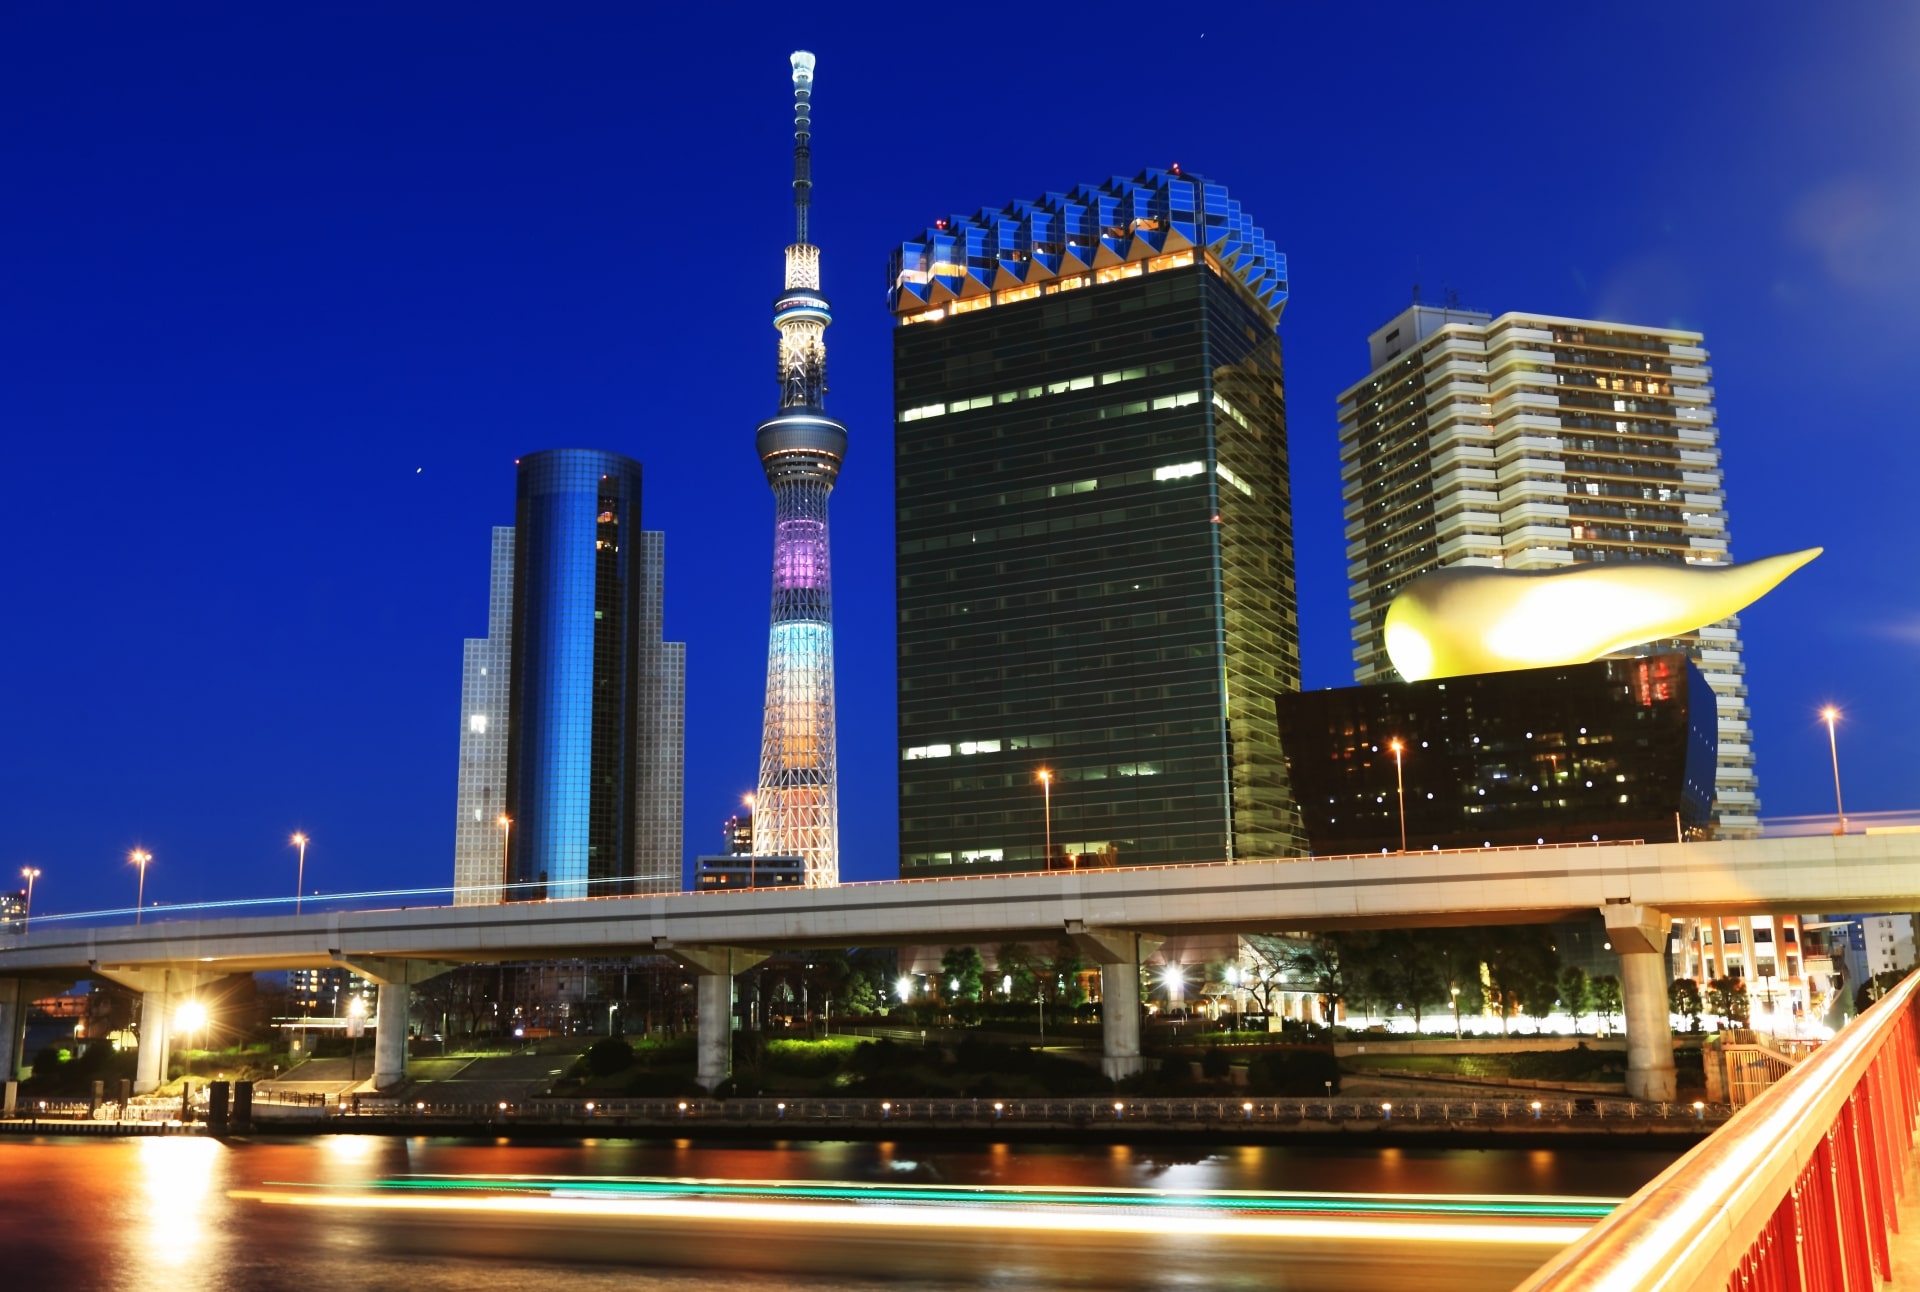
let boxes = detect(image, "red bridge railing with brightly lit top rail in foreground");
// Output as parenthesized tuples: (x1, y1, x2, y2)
(1521, 973, 1920, 1292)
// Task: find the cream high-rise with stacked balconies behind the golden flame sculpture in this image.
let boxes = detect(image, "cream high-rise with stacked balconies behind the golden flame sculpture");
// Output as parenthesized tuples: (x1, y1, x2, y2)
(1340, 305, 1759, 837)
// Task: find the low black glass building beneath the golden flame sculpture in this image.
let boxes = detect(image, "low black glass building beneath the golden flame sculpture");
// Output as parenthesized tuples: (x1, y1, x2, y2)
(1277, 651, 1715, 856)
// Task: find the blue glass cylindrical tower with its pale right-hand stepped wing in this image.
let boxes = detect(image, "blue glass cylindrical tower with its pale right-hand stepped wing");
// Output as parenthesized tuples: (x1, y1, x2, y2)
(503, 449, 685, 898)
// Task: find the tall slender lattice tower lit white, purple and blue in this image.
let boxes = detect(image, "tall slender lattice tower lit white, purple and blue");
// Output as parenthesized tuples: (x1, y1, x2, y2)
(753, 50, 847, 887)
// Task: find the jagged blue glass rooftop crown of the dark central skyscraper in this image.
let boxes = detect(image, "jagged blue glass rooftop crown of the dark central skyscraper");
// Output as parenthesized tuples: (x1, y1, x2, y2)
(887, 167, 1286, 324)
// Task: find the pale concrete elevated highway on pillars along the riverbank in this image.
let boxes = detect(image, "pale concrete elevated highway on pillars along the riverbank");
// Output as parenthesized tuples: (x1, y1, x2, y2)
(0, 833, 1920, 1098)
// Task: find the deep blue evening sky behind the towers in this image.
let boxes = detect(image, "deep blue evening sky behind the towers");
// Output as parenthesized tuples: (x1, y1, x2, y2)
(0, 2, 1920, 910)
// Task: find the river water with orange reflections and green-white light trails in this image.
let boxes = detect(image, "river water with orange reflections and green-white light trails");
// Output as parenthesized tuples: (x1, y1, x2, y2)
(0, 1135, 1672, 1292)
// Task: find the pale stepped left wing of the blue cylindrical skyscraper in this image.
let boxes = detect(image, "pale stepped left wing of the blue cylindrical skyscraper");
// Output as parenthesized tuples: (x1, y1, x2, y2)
(453, 524, 513, 906)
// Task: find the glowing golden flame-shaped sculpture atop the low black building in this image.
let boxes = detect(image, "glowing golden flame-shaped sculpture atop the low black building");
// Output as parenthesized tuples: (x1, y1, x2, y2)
(1386, 547, 1822, 682)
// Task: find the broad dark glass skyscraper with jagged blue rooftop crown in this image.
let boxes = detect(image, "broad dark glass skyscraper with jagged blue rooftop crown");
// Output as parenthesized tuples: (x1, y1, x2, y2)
(891, 171, 1300, 875)
